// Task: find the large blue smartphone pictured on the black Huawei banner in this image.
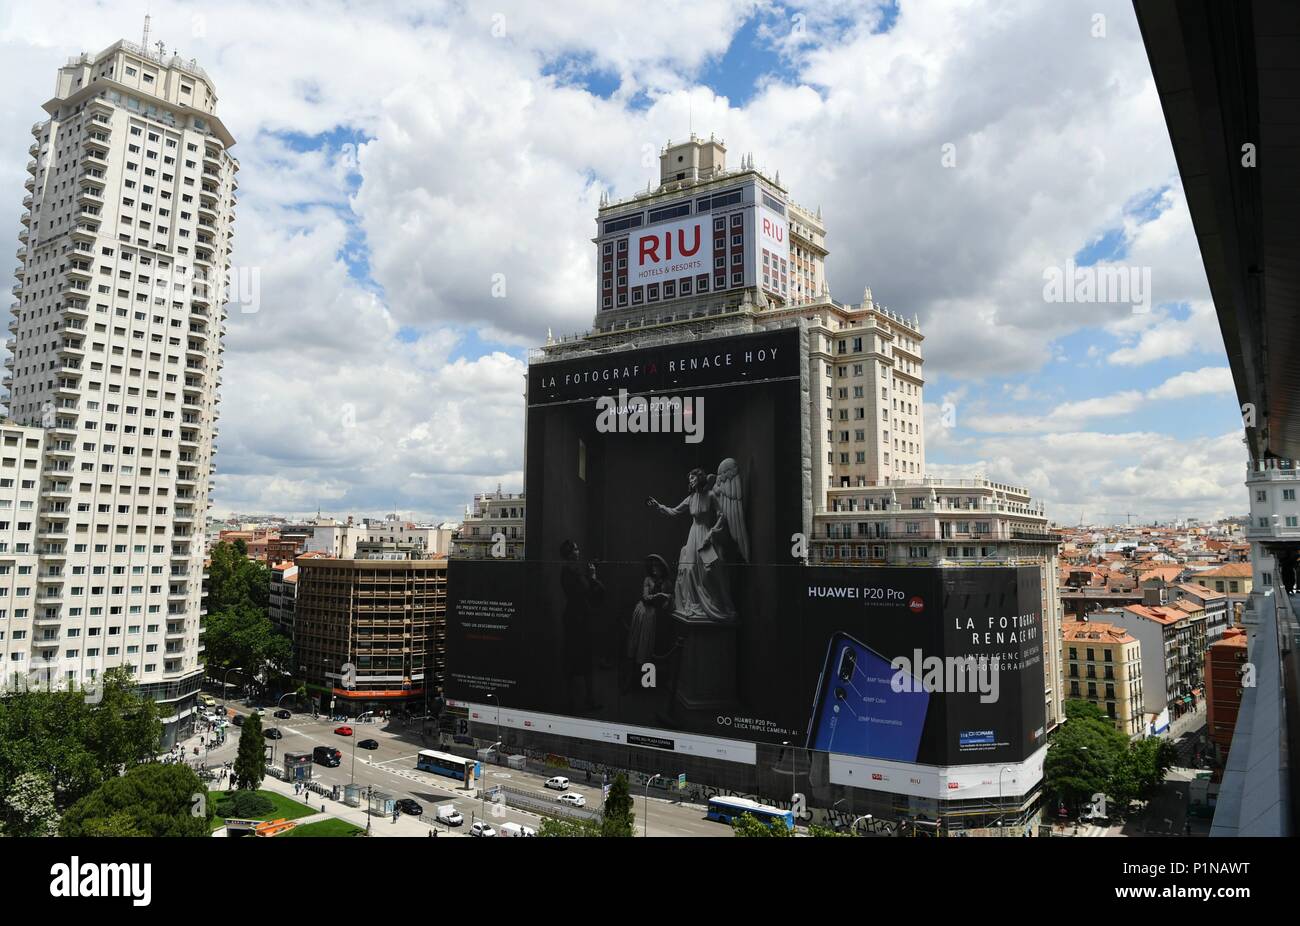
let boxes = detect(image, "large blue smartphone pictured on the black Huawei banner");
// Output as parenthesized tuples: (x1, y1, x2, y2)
(809, 631, 930, 762)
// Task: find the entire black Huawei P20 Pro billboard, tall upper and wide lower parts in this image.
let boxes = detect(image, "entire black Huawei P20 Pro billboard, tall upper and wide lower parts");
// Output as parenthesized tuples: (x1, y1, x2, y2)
(446, 329, 1044, 765)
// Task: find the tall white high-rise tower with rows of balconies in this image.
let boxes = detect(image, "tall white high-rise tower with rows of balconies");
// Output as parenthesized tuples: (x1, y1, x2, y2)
(0, 42, 239, 740)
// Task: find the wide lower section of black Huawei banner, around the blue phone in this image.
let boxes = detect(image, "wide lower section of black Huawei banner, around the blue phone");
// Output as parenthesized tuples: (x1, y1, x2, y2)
(447, 559, 1045, 765)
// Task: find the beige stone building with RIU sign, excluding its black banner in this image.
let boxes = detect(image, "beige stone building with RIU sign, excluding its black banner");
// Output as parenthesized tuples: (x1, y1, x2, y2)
(454, 137, 1062, 826)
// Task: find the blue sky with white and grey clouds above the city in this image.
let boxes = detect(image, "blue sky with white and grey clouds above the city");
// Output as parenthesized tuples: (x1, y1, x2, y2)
(0, 0, 1247, 525)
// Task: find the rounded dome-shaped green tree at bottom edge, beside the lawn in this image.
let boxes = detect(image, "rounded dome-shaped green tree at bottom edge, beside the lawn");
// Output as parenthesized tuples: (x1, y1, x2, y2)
(59, 762, 212, 836)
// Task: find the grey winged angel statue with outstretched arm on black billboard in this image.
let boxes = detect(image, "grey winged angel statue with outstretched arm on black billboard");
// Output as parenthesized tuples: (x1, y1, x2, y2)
(646, 456, 749, 623)
